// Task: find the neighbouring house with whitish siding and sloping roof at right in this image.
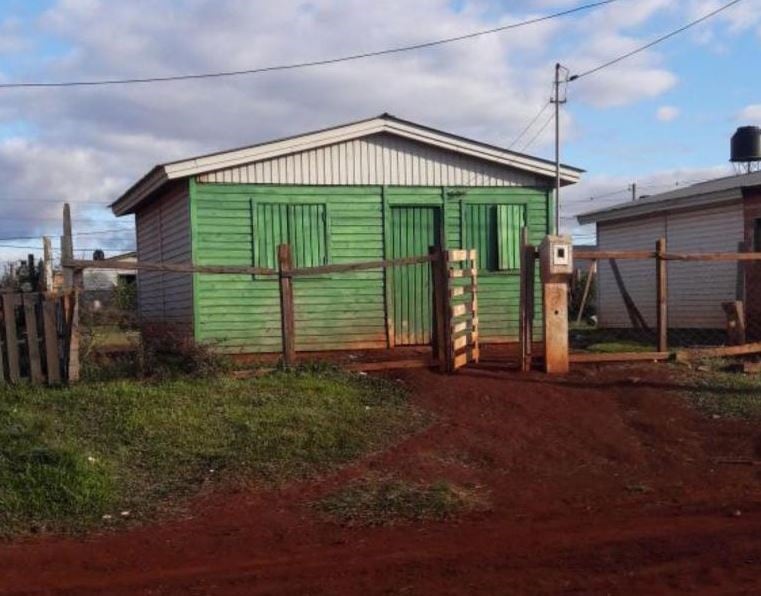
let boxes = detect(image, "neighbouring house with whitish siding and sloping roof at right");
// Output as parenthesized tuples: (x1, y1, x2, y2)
(578, 172, 761, 337)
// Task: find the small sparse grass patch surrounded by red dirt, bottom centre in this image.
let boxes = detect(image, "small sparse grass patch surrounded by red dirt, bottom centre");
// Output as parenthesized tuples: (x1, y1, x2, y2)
(315, 478, 484, 526)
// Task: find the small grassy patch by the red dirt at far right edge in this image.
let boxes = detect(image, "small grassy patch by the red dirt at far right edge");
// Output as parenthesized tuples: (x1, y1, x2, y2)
(689, 361, 761, 419)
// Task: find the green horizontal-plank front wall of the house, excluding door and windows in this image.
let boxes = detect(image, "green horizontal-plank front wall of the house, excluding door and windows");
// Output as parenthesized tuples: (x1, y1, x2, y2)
(190, 182, 551, 353)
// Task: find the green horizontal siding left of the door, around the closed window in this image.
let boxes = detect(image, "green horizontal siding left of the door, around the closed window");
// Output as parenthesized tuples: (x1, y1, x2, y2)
(194, 185, 386, 353)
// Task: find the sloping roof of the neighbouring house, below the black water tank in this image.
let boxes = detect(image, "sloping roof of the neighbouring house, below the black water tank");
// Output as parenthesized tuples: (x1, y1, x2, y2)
(577, 172, 761, 225)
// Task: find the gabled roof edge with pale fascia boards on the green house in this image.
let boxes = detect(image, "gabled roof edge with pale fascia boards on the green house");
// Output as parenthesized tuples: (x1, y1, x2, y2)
(111, 114, 583, 215)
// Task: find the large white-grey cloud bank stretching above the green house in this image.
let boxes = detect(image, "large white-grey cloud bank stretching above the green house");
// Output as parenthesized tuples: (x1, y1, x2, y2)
(0, 0, 748, 258)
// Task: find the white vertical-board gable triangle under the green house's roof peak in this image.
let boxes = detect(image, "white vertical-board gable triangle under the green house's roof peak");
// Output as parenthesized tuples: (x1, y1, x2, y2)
(198, 133, 543, 186)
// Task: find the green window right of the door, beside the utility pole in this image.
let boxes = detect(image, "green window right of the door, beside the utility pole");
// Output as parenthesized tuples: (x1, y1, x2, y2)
(463, 204, 526, 271)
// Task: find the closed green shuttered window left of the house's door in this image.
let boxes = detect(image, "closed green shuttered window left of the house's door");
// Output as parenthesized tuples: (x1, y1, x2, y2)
(253, 203, 328, 269)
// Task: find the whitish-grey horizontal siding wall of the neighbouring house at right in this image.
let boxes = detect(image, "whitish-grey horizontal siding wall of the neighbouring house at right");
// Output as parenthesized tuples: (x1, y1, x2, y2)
(598, 203, 743, 329)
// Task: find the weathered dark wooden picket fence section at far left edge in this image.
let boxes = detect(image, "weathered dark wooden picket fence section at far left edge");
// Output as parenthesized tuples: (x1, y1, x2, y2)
(0, 292, 75, 385)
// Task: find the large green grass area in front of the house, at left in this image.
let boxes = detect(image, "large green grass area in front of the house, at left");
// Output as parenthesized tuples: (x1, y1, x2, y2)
(0, 370, 424, 535)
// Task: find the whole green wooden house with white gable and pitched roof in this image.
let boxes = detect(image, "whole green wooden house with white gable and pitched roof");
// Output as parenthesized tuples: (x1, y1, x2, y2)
(112, 114, 582, 353)
